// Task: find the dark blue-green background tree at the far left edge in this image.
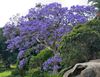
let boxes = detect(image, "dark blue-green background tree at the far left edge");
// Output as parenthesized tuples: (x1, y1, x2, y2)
(0, 28, 17, 68)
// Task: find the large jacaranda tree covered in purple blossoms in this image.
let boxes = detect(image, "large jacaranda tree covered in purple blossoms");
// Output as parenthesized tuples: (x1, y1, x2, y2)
(4, 3, 95, 71)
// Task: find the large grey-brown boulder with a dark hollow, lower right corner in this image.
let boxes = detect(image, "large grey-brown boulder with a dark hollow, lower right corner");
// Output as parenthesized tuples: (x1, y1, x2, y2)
(63, 59, 100, 77)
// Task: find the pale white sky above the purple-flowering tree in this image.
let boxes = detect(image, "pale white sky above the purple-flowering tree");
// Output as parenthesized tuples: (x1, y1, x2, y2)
(0, 0, 87, 27)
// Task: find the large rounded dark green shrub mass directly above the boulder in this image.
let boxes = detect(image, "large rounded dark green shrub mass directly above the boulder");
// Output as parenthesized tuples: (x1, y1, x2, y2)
(60, 20, 100, 67)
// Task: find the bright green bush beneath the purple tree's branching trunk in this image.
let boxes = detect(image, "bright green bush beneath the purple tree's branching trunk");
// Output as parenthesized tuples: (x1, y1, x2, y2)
(29, 48, 53, 68)
